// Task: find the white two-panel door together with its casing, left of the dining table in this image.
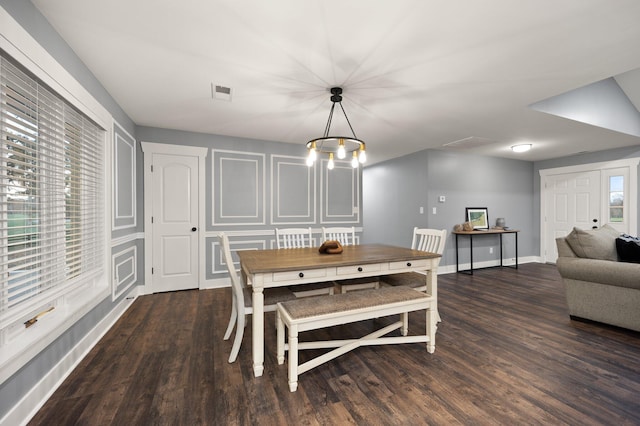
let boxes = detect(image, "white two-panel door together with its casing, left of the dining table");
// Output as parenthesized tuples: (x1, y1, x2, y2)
(142, 142, 207, 294)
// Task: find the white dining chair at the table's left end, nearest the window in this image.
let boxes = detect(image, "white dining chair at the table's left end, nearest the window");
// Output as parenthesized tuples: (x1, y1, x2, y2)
(219, 232, 296, 363)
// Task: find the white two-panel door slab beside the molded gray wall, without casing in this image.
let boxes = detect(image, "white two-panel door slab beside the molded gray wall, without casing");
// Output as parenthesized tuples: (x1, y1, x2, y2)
(151, 154, 199, 293)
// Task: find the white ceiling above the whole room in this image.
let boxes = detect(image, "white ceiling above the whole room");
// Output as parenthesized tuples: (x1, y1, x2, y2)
(32, 0, 640, 164)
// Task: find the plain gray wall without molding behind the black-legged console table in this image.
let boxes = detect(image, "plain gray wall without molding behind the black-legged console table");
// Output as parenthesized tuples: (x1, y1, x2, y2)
(363, 150, 538, 266)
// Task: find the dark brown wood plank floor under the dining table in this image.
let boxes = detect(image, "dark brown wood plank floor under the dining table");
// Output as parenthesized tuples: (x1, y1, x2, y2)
(30, 264, 640, 425)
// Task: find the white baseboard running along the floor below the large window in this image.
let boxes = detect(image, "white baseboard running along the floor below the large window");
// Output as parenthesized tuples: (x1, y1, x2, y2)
(0, 286, 141, 426)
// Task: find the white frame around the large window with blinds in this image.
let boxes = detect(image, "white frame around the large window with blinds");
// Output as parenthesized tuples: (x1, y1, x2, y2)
(0, 7, 114, 383)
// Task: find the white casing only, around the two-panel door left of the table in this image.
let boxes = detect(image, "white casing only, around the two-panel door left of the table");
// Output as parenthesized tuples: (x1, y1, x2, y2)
(140, 142, 209, 294)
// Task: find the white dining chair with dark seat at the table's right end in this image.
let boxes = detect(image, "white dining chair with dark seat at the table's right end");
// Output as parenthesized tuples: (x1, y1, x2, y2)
(380, 227, 447, 291)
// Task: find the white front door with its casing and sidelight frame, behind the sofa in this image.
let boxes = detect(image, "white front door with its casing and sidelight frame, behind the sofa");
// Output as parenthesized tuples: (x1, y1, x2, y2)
(540, 158, 639, 263)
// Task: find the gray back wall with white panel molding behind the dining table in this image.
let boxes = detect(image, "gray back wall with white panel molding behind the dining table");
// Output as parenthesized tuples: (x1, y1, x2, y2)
(136, 127, 362, 279)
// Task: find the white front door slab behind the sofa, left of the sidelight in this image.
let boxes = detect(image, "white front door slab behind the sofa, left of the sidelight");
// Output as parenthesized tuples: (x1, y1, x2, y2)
(543, 170, 602, 262)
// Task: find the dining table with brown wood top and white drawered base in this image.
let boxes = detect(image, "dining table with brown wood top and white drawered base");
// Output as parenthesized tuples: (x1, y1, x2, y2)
(237, 244, 441, 377)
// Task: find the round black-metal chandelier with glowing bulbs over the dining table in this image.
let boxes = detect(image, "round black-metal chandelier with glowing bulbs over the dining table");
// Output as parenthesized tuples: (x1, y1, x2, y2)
(307, 87, 367, 170)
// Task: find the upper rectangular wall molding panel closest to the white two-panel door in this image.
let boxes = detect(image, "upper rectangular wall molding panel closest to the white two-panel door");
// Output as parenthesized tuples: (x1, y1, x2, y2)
(211, 149, 266, 226)
